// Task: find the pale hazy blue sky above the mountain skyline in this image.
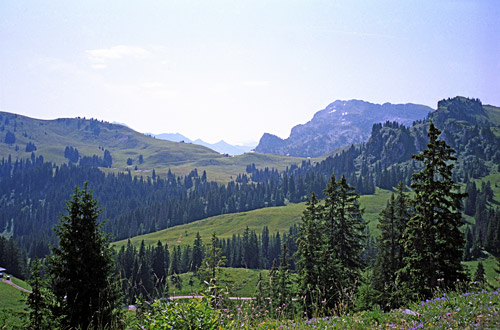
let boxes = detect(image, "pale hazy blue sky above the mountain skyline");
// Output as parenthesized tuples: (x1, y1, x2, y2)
(0, 0, 500, 145)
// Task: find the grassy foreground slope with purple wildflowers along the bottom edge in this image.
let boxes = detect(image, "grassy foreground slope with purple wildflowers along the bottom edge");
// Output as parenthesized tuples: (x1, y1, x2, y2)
(132, 290, 500, 330)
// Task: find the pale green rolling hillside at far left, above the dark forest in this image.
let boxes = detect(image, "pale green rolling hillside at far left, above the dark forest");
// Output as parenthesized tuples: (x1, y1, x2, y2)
(0, 112, 303, 182)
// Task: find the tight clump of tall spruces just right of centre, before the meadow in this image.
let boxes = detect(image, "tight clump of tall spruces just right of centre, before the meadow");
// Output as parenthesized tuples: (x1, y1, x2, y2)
(297, 175, 366, 316)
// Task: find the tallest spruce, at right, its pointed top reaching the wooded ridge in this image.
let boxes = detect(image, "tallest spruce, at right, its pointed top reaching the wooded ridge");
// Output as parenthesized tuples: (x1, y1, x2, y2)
(401, 122, 466, 299)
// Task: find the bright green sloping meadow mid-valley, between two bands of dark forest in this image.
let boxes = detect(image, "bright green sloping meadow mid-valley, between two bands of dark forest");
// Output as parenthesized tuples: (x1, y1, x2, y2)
(113, 189, 391, 248)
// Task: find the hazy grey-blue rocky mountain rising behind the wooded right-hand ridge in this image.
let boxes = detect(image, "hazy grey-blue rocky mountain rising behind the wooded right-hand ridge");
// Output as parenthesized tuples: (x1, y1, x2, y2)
(255, 100, 433, 157)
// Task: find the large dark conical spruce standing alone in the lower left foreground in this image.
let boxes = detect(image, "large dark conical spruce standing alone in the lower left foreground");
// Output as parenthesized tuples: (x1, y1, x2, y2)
(48, 183, 121, 329)
